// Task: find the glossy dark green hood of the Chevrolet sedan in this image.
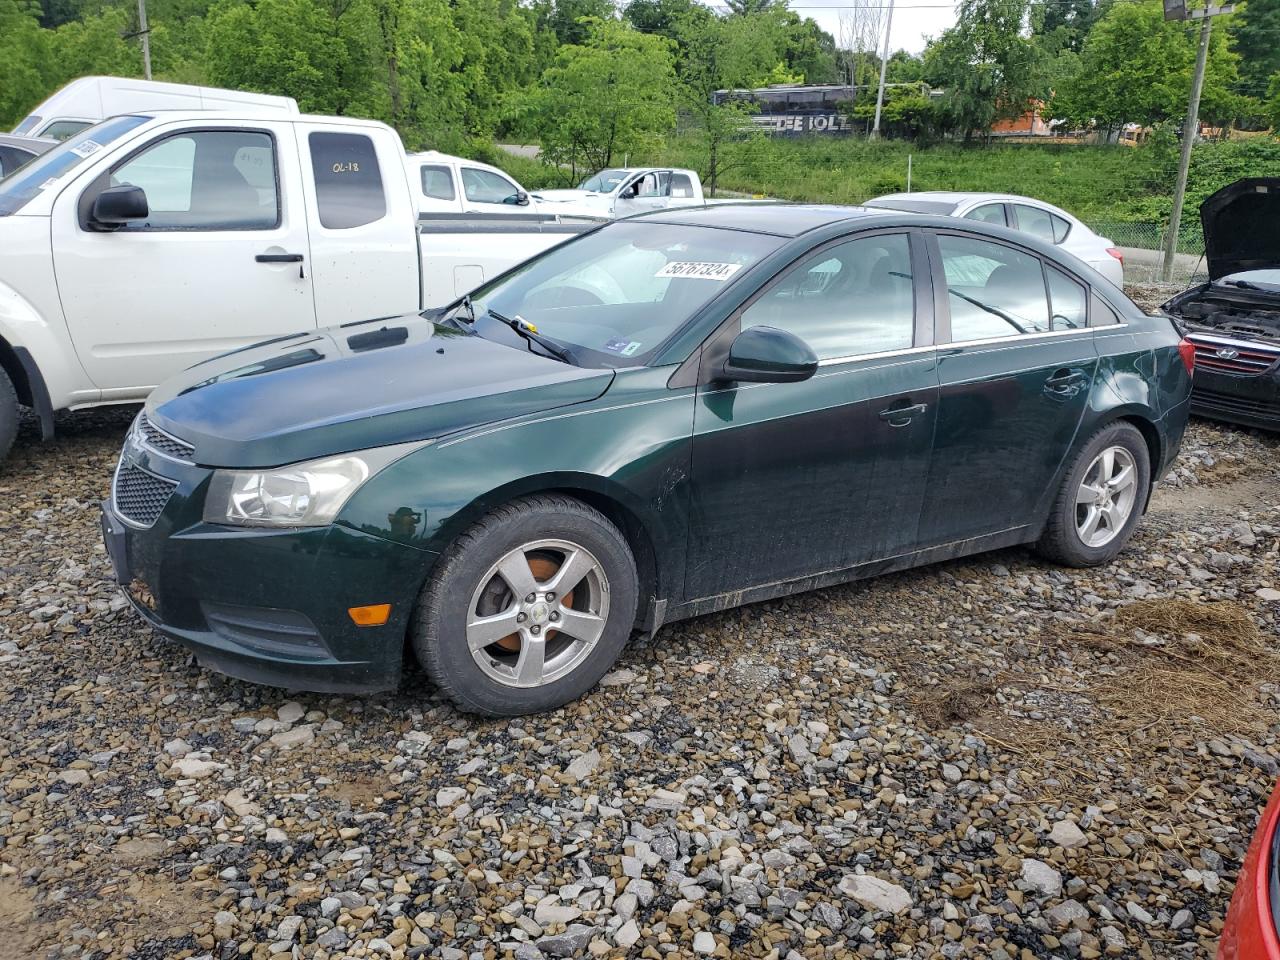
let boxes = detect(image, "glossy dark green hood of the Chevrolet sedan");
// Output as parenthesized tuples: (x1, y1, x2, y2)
(146, 315, 613, 467)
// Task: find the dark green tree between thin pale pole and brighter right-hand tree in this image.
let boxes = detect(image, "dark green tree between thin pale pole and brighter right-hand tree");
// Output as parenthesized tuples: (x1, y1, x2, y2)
(924, 0, 1044, 140)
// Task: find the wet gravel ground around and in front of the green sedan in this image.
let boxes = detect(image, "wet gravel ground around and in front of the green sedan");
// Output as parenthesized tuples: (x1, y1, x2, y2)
(0, 394, 1280, 960)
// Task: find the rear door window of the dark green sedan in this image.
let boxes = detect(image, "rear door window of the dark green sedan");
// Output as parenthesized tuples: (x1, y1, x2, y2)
(938, 234, 1050, 343)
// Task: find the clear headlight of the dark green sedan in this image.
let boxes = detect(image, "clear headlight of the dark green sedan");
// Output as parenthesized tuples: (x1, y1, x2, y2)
(205, 440, 430, 526)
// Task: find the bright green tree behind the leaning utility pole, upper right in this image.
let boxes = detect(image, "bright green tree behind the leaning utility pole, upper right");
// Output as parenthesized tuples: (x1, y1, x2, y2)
(1051, 0, 1239, 129)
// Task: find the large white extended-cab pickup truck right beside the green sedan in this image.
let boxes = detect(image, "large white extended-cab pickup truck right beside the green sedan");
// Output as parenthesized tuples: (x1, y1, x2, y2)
(0, 111, 595, 458)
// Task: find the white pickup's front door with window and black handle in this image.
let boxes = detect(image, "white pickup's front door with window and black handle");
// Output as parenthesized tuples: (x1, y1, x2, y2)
(51, 120, 315, 399)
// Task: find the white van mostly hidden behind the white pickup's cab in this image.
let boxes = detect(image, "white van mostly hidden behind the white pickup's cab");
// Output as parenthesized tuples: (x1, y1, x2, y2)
(13, 77, 298, 140)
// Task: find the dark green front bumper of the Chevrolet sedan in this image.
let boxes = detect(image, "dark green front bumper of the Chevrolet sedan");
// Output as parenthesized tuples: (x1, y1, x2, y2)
(102, 473, 435, 692)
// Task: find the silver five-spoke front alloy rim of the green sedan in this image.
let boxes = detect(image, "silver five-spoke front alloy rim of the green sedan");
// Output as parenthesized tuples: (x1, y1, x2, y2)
(466, 540, 609, 687)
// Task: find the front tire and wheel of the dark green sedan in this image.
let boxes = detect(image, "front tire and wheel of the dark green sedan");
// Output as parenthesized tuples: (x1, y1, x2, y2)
(410, 495, 639, 717)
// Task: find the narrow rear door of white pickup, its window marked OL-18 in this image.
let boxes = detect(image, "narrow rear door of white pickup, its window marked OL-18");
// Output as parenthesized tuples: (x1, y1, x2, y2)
(294, 123, 422, 326)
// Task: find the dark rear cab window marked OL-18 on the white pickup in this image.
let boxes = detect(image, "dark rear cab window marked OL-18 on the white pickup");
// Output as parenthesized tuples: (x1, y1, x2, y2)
(307, 133, 387, 230)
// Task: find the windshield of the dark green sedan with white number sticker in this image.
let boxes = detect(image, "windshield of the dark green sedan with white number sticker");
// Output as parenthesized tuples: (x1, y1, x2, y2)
(471, 221, 782, 367)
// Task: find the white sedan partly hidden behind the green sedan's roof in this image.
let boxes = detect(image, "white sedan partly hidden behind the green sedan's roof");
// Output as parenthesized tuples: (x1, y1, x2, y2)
(864, 191, 1124, 287)
